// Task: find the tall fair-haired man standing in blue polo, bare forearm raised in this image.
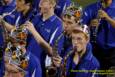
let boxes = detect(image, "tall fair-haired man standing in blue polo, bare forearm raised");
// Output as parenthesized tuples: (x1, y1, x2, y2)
(27, 0, 63, 75)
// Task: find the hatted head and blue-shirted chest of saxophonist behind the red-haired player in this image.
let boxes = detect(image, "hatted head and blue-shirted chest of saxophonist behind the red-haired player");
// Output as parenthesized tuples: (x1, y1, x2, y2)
(62, 3, 84, 56)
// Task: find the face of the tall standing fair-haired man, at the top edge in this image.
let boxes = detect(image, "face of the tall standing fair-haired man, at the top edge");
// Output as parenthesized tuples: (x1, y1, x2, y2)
(39, 0, 53, 14)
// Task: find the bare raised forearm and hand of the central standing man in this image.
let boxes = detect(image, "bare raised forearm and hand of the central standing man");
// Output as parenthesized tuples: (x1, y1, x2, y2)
(26, 22, 52, 55)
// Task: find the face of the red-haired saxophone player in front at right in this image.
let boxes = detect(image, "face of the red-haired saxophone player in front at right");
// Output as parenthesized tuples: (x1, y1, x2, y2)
(72, 33, 88, 52)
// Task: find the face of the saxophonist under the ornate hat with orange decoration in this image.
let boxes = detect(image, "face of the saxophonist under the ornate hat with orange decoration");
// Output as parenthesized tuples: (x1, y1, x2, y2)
(63, 16, 76, 35)
